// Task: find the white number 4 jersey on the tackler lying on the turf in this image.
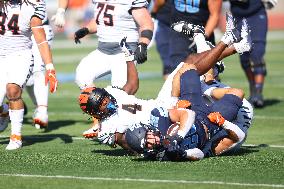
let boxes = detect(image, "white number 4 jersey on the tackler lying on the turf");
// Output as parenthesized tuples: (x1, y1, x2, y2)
(98, 86, 178, 146)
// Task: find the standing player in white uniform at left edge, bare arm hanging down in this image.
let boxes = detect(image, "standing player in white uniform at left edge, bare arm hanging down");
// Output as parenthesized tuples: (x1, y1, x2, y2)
(0, 0, 57, 150)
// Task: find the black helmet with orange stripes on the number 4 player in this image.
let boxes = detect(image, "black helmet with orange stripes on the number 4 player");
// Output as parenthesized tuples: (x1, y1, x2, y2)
(78, 87, 118, 120)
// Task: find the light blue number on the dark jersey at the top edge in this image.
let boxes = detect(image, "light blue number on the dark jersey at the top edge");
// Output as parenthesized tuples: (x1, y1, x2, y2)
(174, 0, 200, 13)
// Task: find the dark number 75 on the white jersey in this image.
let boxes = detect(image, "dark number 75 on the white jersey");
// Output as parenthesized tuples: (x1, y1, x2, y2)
(96, 3, 114, 26)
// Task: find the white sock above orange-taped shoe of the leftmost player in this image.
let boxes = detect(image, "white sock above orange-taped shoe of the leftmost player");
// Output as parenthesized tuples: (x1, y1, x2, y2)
(9, 109, 24, 136)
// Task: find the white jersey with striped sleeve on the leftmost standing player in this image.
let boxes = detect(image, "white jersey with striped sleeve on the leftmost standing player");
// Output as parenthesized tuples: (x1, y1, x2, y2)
(0, 1, 46, 56)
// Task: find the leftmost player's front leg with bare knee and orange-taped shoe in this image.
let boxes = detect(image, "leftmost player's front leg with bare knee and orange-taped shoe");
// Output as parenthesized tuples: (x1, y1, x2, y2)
(6, 50, 32, 150)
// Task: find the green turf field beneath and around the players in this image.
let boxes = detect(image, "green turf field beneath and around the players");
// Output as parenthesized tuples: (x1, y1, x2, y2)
(0, 32, 284, 189)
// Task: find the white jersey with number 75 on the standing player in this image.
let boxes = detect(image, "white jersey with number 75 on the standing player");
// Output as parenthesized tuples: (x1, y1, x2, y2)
(93, 0, 148, 42)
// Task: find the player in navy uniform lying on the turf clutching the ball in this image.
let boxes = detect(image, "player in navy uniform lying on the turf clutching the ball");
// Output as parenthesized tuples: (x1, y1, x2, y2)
(125, 64, 245, 160)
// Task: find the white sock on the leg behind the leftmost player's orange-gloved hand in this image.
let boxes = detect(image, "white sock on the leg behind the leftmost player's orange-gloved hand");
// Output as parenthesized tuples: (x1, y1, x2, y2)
(34, 71, 48, 107)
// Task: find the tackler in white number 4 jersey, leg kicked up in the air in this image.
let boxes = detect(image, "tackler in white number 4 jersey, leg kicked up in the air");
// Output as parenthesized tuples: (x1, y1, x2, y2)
(79, 12, 247, 150)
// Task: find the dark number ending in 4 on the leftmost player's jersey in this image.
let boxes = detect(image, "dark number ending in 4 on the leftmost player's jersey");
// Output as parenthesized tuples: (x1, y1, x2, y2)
(0, 12, 19, 35)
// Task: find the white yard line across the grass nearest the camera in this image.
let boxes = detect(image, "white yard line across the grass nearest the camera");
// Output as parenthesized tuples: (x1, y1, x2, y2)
(0, 174, 284, 188)
